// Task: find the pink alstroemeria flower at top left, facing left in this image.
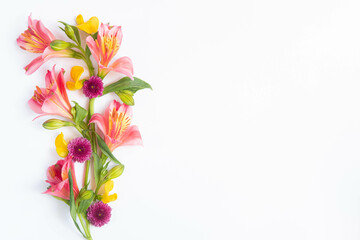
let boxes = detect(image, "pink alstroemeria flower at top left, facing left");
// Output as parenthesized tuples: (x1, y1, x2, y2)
(16, 15, 74, 75)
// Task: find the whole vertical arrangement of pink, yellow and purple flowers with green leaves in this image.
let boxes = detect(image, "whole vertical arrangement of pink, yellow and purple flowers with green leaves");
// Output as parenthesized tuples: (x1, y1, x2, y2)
(17, 15, 151, 239)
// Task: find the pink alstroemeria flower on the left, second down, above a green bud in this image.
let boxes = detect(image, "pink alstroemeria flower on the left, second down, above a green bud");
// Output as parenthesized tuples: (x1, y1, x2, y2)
(28, 65, 73, 120)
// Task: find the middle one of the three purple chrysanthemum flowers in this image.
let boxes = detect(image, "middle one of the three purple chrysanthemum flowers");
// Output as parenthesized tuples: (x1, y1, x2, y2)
(68, 137, 92, 163)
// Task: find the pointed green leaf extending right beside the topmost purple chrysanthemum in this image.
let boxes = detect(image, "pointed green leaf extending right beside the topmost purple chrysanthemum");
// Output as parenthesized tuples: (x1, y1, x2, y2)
(103, 77, 152, 95)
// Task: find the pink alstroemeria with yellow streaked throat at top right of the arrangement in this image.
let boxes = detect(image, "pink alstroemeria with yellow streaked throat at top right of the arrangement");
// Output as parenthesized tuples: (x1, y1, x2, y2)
(86, 23, 134, 79)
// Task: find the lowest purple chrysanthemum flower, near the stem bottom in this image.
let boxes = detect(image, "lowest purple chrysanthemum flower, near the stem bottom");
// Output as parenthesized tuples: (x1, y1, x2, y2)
(86, 201, 111, 227)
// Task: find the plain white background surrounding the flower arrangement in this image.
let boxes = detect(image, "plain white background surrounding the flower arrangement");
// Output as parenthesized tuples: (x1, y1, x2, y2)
(0, 0, 360, 240)
